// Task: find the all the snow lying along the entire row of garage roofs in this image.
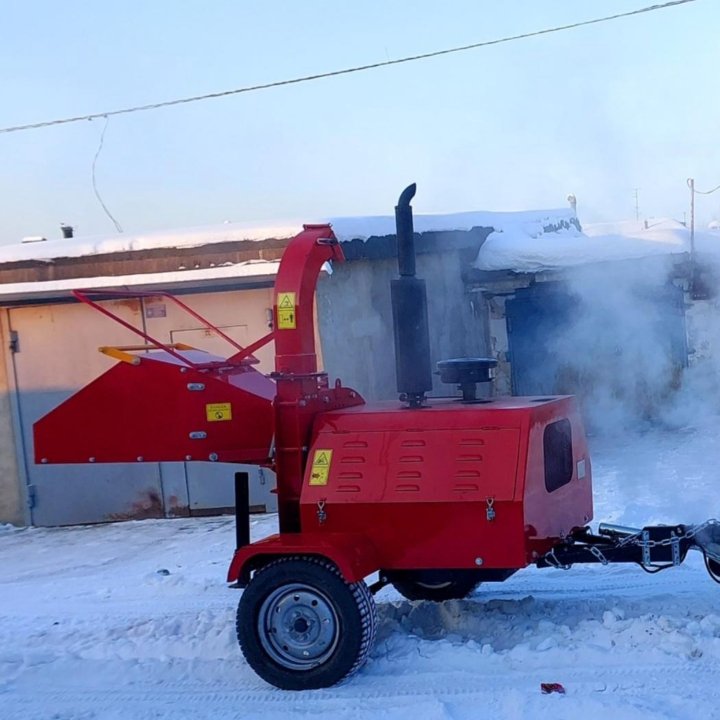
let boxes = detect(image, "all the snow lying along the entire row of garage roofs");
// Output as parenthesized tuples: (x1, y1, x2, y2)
(5, 208, 708, 278)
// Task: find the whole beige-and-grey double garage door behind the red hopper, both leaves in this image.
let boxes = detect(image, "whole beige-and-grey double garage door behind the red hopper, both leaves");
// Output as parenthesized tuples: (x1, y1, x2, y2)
(7, 290, 277, 526)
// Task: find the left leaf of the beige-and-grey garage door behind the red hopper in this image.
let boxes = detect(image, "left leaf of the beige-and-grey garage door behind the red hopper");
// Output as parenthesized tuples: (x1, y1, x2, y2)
(9, 301, 163, 525)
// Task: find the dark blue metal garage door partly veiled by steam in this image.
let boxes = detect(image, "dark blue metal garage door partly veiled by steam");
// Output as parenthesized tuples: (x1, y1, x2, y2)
(506, 278, 688, 396)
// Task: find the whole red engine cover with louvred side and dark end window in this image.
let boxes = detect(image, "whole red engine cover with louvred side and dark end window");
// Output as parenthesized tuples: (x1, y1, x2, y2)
(301, 397, 592, 569)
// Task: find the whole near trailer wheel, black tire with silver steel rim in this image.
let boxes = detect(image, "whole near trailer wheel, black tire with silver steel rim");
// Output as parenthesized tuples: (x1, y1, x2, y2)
(236, 557, 377, 690)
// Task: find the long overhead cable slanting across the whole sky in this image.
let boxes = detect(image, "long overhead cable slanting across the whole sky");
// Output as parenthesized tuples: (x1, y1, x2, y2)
(0, 0, 696, 133)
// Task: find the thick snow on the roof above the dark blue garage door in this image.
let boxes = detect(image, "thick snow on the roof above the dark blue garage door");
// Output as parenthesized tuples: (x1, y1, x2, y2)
(475, 218, 720, 272)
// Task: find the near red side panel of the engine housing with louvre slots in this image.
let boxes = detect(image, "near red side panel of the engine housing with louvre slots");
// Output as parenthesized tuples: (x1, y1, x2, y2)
(301, 420, 527, 568)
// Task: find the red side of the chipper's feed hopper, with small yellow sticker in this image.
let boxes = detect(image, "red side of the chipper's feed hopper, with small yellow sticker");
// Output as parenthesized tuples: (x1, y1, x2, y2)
(34, 358, 274, 463)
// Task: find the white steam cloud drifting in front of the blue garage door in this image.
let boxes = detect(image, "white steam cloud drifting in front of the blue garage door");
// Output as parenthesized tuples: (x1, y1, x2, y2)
(548, 262, 685, 433)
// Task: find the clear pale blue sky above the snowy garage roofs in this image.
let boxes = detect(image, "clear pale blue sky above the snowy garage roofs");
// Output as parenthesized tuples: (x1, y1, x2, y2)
(0, 0, 720, 244)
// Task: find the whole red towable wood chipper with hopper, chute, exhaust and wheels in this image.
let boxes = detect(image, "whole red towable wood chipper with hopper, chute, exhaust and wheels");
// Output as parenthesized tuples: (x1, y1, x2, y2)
(35, 185, 720, 689)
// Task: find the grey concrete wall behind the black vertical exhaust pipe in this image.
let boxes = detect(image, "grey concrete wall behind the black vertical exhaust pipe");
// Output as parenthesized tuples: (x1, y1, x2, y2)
(317, 249, 488, 400)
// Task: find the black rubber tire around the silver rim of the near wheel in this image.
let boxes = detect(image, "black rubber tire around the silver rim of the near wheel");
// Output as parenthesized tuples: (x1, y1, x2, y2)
(236, 557, 377, 690)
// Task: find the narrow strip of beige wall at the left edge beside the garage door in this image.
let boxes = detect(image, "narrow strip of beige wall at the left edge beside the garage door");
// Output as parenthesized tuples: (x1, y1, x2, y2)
(0, 322, 25, 525)
